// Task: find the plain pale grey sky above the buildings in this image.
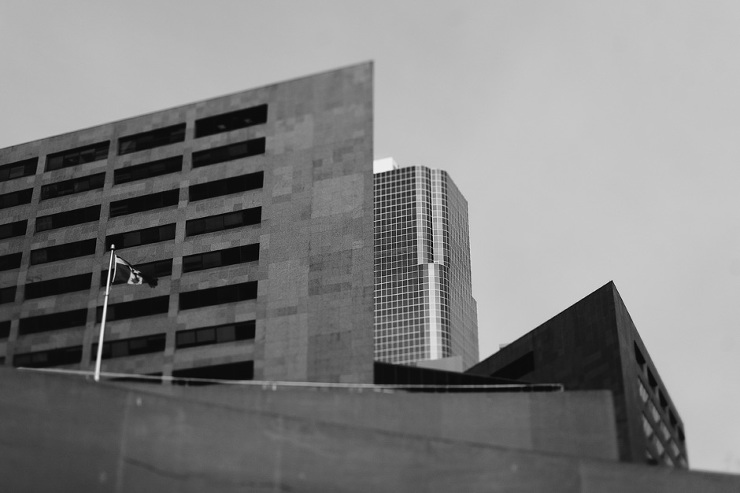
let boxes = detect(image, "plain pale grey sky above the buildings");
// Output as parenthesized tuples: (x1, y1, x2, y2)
(0, 0, 740, 474)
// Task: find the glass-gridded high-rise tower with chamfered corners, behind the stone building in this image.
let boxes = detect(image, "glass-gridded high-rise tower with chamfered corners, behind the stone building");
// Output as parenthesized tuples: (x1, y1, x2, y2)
(374, 159, 478, 371)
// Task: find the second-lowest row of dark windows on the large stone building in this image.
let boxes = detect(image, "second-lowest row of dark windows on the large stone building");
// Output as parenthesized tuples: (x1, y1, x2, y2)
(10, 320, 255, 368)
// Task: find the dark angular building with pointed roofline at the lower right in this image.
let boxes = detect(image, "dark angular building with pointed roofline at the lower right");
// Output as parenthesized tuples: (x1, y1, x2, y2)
(467, 282, 688, 468)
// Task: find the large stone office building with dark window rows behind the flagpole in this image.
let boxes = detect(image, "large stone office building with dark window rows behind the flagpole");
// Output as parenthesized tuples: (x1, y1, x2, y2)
(0, 63, 373, 383)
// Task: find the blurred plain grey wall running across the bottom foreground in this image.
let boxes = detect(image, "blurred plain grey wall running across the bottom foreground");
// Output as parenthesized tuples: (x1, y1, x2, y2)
(0, 370, 740, 493)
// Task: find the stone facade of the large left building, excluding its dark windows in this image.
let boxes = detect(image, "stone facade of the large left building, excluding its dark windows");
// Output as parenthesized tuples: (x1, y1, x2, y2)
(0, 63, 373, 383)
